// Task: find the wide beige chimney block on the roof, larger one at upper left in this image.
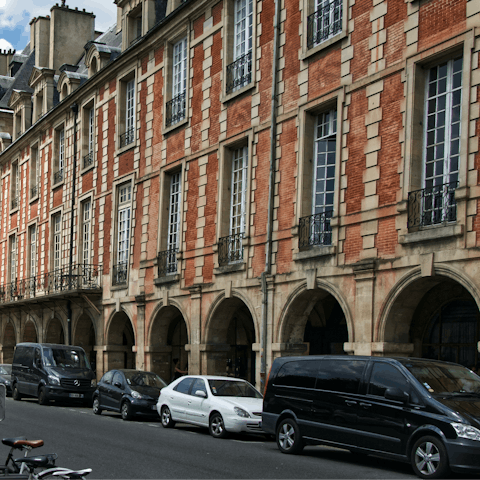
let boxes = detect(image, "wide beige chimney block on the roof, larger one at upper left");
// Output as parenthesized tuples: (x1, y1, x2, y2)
(48, 3, 95, 72)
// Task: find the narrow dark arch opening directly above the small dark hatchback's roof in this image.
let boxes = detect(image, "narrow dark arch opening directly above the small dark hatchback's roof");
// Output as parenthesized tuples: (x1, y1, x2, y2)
(105, 312, 136, 371)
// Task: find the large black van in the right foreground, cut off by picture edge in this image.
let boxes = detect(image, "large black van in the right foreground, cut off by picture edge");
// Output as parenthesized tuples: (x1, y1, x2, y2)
(262, 355, 480, 479)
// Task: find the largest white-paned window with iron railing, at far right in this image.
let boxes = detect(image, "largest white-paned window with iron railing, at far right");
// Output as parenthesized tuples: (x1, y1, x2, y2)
(408, 55, 463, 229)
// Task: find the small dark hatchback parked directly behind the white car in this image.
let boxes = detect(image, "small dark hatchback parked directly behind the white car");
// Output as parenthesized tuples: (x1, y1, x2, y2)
(93, 370, 167, 420)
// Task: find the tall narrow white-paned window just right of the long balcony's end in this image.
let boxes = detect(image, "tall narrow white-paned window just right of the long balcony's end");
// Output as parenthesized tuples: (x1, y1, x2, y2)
(113, 183, 132, 285)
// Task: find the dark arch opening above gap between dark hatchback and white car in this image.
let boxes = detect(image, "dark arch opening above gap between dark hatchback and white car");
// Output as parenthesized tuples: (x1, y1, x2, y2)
(147, 306, 189, 383)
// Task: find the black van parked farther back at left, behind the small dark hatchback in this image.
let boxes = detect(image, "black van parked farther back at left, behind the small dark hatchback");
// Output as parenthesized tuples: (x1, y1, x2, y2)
(12, 343, 96, 405)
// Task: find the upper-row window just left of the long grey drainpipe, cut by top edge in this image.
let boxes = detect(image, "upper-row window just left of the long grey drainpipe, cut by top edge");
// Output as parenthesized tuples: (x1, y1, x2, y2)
(226, 0, 253, 94)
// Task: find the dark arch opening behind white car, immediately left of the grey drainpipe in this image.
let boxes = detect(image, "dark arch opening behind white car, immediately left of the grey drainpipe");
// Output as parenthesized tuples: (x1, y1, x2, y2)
(203, 297, 257, 384)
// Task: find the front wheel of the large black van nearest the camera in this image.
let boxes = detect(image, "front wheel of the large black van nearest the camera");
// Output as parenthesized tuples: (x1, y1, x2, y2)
(411, 436, 449, 480)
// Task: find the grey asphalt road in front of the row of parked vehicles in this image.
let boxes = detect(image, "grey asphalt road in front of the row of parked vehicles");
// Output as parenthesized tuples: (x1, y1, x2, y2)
(0, 398, 422, 480)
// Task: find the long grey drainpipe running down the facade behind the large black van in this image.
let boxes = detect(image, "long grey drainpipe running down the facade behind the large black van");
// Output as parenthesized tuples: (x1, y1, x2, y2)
(260, 0, 281, 389)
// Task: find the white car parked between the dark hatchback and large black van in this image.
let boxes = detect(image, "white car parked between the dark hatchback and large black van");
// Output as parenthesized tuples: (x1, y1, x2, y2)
(157, 375, 263, 438)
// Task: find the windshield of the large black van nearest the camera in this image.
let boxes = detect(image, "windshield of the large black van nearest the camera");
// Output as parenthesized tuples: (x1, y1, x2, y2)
(405, 362, 480, 395)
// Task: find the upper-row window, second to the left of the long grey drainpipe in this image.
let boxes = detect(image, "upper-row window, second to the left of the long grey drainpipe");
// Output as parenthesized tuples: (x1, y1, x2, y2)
(165, 37, 187, 127)
